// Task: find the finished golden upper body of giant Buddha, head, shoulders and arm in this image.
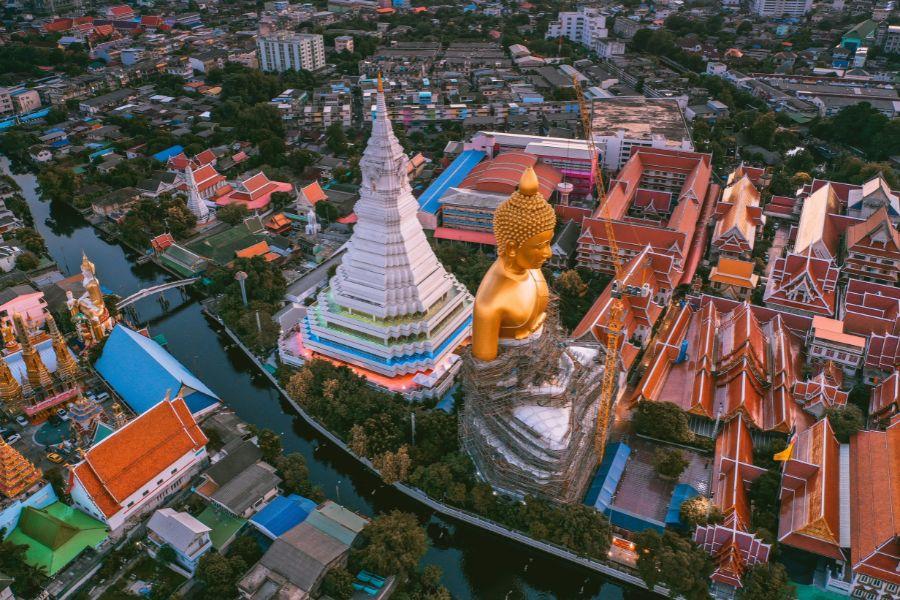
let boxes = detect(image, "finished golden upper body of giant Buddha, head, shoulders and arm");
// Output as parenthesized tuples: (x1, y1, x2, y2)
(472, 167, 556, 361)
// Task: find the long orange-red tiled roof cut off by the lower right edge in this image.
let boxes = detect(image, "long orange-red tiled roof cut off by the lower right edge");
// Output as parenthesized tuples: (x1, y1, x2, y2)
(850, 425, 900, 584)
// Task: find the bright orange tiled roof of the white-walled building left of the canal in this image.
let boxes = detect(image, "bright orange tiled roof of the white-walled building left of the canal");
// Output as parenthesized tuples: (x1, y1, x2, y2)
(73, 398, 207, 517)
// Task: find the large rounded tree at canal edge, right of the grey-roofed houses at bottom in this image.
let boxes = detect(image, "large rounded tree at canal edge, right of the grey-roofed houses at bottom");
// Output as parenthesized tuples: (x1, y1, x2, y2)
(350, 510, 428, 577)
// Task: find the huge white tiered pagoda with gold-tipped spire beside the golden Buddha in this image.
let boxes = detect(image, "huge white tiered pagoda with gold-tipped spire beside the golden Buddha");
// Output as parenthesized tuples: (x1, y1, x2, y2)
(300, 82, 474, 400)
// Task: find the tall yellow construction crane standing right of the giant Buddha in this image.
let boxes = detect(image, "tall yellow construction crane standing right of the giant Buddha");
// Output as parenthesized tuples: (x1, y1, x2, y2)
(572, 74, 625, 463)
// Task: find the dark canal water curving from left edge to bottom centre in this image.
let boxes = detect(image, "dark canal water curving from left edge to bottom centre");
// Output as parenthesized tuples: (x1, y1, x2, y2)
(0, 157, 650, 600)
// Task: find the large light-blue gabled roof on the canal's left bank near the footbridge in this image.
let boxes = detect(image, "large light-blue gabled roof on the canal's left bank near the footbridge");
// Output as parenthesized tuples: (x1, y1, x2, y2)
(95, 325, 220, 414)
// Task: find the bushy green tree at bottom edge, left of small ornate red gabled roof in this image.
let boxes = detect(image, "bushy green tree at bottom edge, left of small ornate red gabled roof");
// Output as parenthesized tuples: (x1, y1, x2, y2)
(635, 529, 713, 600)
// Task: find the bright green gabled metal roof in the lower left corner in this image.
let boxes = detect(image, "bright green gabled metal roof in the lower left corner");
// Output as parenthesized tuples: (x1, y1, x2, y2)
(7, 502, 109, 576)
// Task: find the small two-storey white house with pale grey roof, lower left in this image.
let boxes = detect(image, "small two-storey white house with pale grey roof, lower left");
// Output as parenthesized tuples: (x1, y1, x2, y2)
(147, 508, 212, 575)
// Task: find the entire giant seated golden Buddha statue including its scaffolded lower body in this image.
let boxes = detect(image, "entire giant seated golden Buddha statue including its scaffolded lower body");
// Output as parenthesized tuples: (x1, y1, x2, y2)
(460, 168, 602, 503)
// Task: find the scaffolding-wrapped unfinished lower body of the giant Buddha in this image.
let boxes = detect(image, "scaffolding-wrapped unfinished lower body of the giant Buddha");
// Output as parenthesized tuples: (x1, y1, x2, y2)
(459, 300, 603, 503)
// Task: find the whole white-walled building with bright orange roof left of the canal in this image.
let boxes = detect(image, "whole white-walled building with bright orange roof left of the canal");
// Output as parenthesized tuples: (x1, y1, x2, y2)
(68, 398, 207, 535)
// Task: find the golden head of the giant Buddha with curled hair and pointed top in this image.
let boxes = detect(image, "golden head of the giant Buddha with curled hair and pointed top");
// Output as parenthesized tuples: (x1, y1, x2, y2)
(494, 167, 556, 272)
